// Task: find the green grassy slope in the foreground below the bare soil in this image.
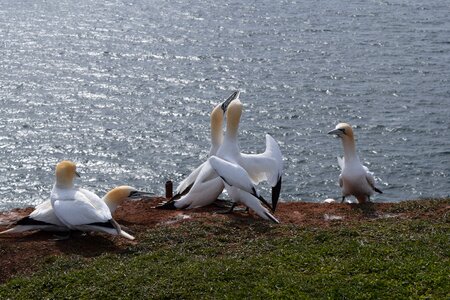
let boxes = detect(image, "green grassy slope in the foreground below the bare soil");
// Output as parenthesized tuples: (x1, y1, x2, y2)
(0, 199, 450, 299)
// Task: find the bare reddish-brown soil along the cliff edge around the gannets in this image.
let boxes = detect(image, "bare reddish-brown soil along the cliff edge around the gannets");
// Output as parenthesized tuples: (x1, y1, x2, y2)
(0, 197, 450, 283)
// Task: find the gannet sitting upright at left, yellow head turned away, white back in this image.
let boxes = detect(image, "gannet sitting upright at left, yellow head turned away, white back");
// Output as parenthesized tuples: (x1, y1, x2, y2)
(50, 161, 134, 240)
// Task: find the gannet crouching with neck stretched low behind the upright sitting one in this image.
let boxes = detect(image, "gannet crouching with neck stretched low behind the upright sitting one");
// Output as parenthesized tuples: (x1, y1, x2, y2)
(0, 185, 149, 234)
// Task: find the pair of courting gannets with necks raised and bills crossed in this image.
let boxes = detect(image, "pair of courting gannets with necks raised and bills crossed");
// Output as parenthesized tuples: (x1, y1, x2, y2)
(158, 91, 283, 223)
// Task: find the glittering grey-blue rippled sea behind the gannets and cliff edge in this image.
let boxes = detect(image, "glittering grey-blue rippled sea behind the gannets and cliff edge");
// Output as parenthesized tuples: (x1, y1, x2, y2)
(0, 0, 450, 210)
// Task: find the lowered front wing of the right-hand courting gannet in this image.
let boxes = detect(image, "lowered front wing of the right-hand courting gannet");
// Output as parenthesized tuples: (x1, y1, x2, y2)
(209, 156, 280, 223)
